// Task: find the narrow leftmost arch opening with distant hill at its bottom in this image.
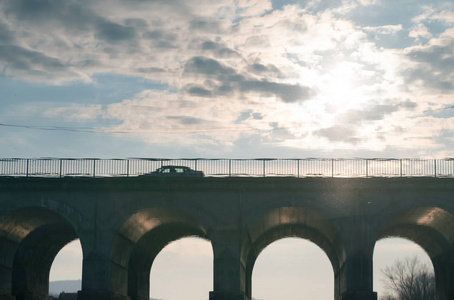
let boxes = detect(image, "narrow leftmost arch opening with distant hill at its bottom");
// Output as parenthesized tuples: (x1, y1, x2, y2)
(49, 239, 83, 298)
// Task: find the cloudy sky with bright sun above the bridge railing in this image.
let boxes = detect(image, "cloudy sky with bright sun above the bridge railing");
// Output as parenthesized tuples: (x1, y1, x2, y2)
(0, 0, 454, 299)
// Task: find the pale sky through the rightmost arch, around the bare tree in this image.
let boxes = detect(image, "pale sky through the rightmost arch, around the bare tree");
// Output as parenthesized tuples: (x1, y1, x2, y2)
(373, 237, 434, 299)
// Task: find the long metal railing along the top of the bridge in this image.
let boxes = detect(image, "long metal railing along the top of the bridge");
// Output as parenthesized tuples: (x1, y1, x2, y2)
(0, 158, 454, 177)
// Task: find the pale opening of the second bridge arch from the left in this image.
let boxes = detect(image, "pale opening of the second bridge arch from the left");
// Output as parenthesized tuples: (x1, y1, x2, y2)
(150, 237, 213, 300)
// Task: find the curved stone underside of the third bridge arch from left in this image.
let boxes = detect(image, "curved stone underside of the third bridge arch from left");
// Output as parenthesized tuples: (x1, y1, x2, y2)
(241, 207, 345, 299)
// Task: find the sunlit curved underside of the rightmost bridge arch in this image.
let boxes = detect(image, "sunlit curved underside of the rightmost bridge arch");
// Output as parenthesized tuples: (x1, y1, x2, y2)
(379, 207, 454, 300)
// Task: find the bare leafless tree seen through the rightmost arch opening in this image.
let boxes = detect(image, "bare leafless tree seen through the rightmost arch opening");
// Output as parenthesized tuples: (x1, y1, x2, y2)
(382, 256, 435, 300)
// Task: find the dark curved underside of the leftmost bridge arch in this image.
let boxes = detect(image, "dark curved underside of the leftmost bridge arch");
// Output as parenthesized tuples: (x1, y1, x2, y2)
(0, 206, 82, 300)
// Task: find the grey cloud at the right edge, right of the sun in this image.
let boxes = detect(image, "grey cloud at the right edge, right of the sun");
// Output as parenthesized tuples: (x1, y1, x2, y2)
(402, 41, 454, 92)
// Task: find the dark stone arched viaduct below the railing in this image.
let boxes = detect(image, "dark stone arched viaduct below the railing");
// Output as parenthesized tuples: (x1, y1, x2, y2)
(0, 177, 454, 300)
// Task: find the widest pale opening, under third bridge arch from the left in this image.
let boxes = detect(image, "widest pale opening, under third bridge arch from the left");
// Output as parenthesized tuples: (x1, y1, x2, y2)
(252, 238, 334, 300)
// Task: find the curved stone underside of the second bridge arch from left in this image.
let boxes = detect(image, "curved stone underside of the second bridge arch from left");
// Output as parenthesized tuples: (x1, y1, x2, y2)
(110, 207, 209, 300)
